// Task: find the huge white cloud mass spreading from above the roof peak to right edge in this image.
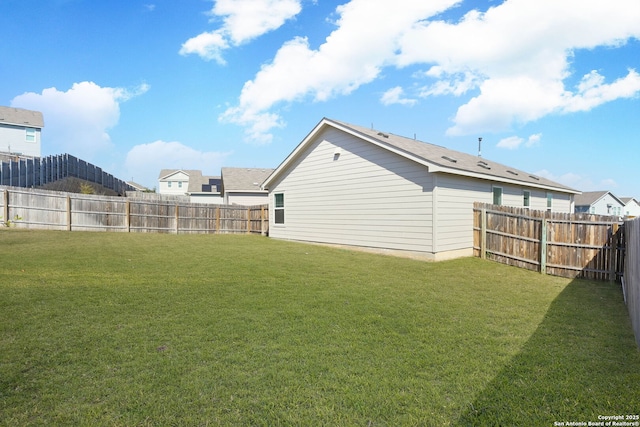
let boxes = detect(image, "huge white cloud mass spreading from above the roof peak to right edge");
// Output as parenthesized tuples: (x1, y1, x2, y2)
(221, 0, 640, 140)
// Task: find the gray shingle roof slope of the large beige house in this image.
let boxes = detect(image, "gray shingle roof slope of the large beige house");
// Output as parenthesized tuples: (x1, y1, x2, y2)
(325, 119, 579, 193)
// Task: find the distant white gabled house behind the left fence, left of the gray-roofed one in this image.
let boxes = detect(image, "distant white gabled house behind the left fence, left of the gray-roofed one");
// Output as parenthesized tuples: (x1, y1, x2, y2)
(158, 169, 222, 204)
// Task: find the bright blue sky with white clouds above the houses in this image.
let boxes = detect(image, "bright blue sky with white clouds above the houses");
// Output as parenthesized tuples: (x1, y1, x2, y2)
(0, 0, 640, 199)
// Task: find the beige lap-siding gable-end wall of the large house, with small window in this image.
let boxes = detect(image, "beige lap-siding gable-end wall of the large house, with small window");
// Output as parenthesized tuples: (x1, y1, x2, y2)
(269, 129, 433, 252)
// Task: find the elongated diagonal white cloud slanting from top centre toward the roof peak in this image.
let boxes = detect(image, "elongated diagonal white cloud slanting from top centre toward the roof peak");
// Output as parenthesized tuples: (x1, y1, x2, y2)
(221, 0, 458, 141)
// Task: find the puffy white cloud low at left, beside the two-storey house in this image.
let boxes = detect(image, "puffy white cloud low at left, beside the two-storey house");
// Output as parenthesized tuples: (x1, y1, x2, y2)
(11, 82, 149, 161)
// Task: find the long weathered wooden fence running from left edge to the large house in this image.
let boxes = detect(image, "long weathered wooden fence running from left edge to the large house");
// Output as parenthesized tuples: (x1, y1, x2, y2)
(0, 187, 269, 235)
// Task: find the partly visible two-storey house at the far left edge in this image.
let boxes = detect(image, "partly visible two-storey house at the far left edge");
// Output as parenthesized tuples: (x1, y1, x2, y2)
(0, 107, 44, 157)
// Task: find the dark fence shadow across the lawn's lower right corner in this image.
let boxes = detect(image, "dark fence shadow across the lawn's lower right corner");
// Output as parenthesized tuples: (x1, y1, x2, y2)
(457, 280, 640, 426)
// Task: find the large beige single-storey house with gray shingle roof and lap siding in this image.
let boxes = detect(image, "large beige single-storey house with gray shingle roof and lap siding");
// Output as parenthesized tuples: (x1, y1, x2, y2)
(263, 118, 580, 259)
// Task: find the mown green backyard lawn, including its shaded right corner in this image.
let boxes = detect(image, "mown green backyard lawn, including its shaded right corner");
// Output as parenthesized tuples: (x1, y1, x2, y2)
(0, 230, 640, 426)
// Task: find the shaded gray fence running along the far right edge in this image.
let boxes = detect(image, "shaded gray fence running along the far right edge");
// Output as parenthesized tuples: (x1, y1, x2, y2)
(622, 218, 640, 347)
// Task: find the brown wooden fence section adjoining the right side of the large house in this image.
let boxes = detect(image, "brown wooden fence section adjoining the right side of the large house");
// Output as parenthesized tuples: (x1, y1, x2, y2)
(473, 203, 624, 281)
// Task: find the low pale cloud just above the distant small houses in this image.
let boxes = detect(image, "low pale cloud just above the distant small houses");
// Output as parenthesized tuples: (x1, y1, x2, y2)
(123, 141, 231, 188)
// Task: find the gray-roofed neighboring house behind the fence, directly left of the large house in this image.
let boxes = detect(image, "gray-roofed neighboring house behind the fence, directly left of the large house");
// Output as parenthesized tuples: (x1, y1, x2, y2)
(221, 168, 273, 206)
